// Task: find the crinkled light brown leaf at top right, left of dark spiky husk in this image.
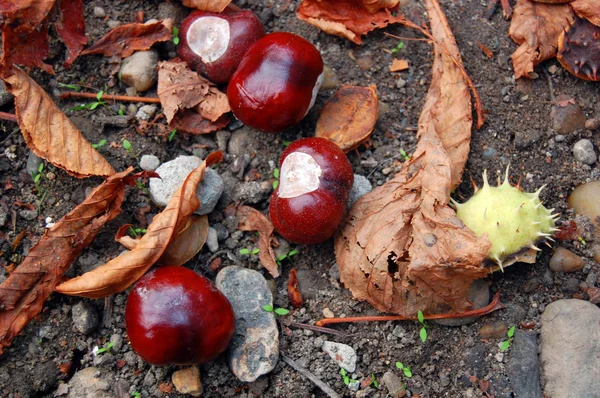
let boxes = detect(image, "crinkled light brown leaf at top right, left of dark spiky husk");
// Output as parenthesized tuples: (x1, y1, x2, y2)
(508, 0, 573, 79)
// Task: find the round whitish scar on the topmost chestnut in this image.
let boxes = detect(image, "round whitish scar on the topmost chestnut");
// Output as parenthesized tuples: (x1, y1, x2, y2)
(186, 17, 231, 63)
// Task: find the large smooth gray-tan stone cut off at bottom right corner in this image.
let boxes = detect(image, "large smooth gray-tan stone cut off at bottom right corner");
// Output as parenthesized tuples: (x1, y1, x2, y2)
(540, 299, 600, 398)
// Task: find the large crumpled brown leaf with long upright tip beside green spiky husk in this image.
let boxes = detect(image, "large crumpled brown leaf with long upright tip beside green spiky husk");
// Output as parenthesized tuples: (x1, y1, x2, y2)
(335, 0, 490, 316)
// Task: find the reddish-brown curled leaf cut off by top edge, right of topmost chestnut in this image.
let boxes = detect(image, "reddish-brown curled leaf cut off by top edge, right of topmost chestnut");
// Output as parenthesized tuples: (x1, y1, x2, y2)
(296, 0, 403, 44)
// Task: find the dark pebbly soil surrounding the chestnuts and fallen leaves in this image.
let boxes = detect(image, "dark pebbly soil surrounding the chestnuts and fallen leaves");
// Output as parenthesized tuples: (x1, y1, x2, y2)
(0, 0, 600, 398)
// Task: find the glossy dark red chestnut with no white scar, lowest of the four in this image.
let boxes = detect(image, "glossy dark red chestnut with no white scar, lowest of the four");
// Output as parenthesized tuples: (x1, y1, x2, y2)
(125, 266, 235, 365)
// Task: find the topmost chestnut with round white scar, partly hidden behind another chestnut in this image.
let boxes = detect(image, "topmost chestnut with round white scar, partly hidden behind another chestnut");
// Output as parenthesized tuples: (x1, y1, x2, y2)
(177, 10, 265, 83)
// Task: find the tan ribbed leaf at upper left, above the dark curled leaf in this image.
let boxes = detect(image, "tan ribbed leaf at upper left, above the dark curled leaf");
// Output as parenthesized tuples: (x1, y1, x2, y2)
(5, 68, 115, 178)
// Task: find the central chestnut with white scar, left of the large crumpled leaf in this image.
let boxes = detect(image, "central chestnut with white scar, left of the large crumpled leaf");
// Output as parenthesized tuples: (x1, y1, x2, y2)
(269, 137, 354, 244)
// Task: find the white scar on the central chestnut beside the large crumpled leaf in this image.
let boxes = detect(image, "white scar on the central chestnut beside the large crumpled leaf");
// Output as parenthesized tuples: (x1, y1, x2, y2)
(279, 152, 323, 198)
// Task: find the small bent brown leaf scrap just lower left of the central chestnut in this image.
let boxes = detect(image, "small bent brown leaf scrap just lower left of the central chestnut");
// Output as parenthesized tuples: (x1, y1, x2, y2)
(235, 205, 279, 278)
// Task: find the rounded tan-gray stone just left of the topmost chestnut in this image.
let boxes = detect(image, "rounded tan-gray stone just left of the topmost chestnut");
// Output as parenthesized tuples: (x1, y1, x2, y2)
(119, 50, 158, 92)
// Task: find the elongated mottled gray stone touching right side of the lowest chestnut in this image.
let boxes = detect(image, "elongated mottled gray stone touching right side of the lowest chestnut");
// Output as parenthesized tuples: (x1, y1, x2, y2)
(216, 266, 279, 382)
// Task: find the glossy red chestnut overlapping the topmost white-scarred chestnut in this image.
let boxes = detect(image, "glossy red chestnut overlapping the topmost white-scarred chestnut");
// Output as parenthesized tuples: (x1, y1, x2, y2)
(227, 32, 323, 133)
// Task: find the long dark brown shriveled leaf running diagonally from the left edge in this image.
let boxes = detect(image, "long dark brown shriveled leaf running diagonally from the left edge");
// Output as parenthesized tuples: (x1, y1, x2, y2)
(0, 168, 135, 353)
